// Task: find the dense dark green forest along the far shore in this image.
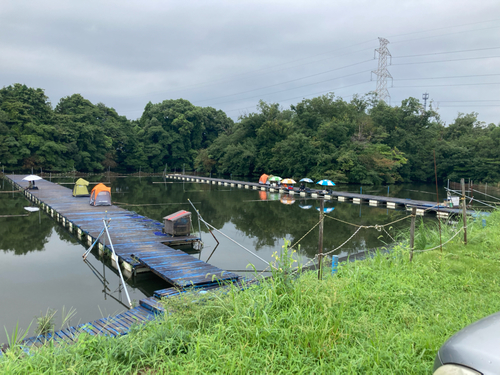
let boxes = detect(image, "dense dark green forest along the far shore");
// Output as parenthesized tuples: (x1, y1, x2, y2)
(0, 84, 500, 184)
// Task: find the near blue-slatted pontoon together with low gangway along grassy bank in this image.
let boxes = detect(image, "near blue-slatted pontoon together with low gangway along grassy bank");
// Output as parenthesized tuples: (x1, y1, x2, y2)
(0, 175, 244, 354)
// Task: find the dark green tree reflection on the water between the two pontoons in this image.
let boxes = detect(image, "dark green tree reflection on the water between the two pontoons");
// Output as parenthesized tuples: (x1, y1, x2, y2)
(113, 178, 409, 256)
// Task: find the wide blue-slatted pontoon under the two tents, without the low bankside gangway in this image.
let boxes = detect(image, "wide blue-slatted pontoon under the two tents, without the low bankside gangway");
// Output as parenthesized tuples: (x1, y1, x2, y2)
(6, 175, 240, 287)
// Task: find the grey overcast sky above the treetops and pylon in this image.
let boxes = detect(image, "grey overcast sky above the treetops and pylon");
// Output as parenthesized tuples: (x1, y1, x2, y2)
(0, 0, 500, 125)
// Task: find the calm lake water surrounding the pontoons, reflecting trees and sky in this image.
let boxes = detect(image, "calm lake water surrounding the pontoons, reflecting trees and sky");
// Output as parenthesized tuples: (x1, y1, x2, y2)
(0, 176, 445, 343)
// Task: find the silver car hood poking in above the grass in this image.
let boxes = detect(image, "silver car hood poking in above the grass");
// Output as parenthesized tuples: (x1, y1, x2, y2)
(438, 312, 500, 375)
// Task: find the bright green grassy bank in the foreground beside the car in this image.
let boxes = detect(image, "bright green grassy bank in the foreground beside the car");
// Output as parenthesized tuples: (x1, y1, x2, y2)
(0, 213, 500, 374)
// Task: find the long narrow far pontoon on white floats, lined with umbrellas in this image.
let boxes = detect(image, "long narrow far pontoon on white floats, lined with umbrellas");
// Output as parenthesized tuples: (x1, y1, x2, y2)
(171, 174, 474, 217)
